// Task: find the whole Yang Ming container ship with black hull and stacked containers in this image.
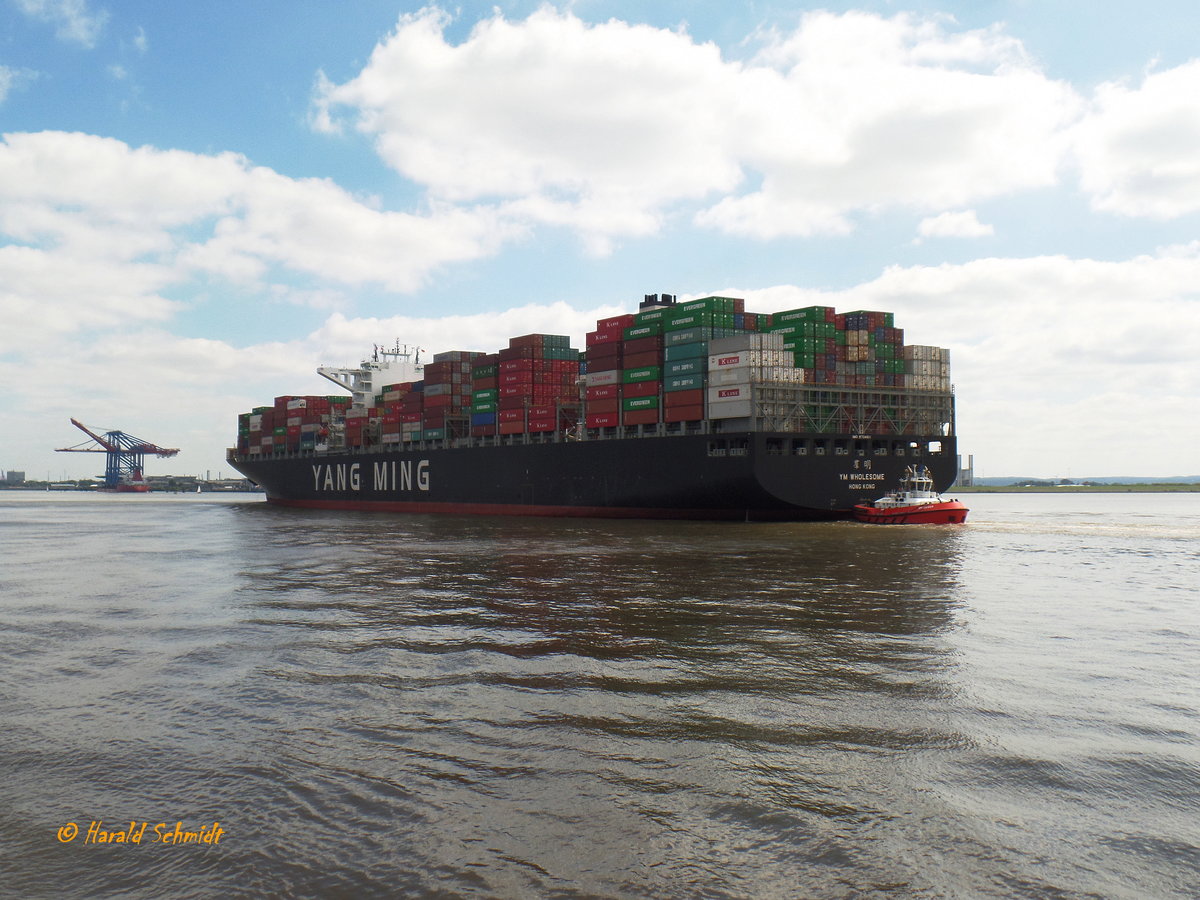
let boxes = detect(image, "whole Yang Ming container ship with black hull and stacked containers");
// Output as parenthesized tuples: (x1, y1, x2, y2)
(228, 294, 958, 521)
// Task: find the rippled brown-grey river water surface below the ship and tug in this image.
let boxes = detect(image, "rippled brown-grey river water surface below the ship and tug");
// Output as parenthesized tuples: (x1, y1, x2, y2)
(0, 492, 1200, 900)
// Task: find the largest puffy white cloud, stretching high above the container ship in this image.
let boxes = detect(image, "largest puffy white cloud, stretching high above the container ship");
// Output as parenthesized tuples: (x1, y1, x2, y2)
(312, 7, 1079, 252)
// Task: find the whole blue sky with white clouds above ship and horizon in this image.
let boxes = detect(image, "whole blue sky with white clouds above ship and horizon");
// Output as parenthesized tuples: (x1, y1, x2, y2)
(0, 0, 1200, 480)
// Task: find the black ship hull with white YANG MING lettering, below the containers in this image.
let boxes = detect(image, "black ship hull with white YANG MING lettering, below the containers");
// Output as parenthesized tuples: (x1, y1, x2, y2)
(230, 432, 958, 521)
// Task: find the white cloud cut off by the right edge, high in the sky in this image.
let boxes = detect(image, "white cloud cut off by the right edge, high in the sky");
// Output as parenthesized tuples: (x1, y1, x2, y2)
(1074, 60, 1200, 218)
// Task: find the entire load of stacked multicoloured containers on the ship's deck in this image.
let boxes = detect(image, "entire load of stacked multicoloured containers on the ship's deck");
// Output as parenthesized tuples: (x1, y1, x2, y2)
(231, 295, 952, 454)
